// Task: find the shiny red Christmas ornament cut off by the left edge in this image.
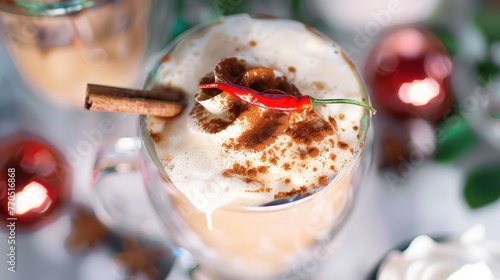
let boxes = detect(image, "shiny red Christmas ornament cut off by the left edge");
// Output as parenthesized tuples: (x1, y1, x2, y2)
(0, 135, 72, 229)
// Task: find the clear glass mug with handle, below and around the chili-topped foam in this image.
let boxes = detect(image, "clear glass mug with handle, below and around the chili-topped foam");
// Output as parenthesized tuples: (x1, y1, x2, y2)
(95, 13, 371, 280)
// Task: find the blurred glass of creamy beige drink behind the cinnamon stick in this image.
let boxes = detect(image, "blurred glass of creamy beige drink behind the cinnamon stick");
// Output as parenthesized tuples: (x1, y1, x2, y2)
(0, 0, 169, 108)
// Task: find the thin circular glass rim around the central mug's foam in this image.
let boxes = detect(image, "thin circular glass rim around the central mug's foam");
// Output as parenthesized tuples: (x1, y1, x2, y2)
(139, 14, 372, 211)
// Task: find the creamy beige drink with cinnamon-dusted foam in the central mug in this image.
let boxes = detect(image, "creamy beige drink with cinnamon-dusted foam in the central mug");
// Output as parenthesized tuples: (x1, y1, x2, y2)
(141, 15, 370, 279)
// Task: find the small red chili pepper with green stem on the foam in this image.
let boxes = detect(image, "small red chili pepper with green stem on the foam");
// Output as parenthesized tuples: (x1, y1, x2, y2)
(198, 82, 376, 113)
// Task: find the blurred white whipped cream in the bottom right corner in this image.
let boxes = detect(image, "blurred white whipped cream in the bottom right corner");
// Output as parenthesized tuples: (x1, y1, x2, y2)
(377, 225, 500, 280)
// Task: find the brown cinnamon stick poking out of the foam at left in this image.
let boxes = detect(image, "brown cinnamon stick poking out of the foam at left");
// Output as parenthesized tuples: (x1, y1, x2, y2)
(85, 84, 184, 117)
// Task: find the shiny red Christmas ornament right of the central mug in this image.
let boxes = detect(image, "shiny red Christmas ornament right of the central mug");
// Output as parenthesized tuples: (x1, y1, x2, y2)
(364, 27, 453, 122)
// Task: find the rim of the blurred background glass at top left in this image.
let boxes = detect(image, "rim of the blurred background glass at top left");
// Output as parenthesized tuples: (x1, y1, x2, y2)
(0, 0, 114, 17)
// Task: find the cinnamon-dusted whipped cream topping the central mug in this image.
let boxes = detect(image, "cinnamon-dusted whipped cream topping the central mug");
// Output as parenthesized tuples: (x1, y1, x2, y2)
(149, 15, 369, 225)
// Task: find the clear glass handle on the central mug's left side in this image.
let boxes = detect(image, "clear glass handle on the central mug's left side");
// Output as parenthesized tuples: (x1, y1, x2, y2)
(93, 137, 169, 245)
